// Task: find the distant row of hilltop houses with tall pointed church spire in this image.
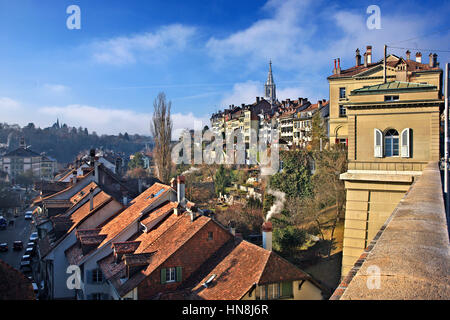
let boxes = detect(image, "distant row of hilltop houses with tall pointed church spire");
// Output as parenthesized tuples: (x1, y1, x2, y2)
(210, 63, 329, 159)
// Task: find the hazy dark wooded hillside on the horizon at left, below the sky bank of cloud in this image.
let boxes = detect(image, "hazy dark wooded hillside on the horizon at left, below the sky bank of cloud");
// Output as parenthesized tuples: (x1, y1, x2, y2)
(0, 121, 151, 163)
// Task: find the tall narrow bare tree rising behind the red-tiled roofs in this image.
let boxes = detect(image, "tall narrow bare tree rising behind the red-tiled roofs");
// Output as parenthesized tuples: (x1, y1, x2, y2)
(150, 92, 172, 183)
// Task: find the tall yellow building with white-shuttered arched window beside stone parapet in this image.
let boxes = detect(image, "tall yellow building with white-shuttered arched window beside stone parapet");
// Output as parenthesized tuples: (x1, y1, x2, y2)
(330, 46, 443, 276)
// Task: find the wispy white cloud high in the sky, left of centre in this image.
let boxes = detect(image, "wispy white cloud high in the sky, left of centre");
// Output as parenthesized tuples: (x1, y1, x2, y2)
(92, 24, 196, 65)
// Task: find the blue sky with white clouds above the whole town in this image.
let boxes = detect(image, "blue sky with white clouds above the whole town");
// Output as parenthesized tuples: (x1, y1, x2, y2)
(0, 0, 450, 134)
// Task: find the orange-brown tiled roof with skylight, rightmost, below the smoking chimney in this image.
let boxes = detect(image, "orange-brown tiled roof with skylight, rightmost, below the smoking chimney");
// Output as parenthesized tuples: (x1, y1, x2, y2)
(186, 240, 320, 300)
